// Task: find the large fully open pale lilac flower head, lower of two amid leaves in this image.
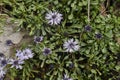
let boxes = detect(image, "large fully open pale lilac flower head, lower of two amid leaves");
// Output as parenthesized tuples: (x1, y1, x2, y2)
(63, 39, 80, 52)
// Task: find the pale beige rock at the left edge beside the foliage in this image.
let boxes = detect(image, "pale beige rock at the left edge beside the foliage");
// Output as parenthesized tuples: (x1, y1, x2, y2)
(0, 21, 25, 56)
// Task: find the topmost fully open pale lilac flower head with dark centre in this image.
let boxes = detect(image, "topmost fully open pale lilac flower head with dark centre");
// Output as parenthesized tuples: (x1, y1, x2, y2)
(45, 11, 63, 25)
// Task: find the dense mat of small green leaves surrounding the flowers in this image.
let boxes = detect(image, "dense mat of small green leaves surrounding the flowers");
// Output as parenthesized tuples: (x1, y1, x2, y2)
(0, 0, 120, 80)
